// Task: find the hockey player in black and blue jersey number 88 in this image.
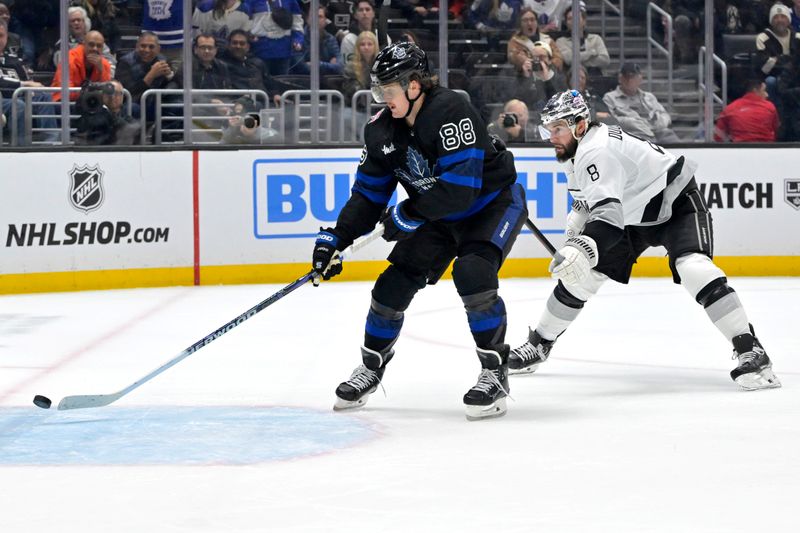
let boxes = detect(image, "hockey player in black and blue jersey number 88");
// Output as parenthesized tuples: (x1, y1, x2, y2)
(312, 42, 527, 420)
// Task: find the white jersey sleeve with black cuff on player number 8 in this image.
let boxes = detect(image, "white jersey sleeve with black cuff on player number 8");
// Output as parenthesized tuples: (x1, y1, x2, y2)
(575, 148, 625, 254)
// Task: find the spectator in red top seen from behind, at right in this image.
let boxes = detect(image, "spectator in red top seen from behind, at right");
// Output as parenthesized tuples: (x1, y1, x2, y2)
(714, 80, 779, 143)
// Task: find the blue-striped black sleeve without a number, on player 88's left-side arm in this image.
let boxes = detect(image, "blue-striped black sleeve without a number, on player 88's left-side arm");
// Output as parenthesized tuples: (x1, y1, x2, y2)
(334, 115, 397, 249)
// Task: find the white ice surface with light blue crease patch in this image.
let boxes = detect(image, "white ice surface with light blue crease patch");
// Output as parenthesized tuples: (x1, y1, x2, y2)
(0, 274, 800, 533)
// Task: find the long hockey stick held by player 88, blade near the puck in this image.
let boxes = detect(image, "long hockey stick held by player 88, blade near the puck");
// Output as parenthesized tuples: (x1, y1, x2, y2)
(58, 224, 383, 411)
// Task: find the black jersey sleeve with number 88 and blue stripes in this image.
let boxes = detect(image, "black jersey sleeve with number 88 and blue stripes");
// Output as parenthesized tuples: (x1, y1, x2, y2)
(404, 96, 484, 220)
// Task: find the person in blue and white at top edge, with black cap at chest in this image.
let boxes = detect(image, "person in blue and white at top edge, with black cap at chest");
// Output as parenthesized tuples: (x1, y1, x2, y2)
(250, 0, 303, 76)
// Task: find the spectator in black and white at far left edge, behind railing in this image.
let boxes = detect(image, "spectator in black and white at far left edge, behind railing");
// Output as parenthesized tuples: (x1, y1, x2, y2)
(0, 19, 56, 145)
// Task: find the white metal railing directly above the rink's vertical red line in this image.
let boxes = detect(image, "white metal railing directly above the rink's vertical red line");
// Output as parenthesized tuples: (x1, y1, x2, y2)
(140, 89, 269, 144)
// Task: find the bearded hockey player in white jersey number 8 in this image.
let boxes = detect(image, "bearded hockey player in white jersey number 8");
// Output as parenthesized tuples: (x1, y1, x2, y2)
(509, 90, 781, 390)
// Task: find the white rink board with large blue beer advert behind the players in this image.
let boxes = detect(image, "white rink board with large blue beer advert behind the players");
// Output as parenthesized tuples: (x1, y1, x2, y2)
(200, 148, 800, 265)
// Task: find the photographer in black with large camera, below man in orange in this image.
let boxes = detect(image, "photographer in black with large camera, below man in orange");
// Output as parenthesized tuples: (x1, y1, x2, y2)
(75, 80, 139, 146)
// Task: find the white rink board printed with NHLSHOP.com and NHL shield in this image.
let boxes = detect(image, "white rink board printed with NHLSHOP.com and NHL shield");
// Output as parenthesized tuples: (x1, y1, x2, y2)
(0, 152, 193, 274)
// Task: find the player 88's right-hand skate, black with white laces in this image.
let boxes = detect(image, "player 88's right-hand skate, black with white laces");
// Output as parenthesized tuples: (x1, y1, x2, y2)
(464, 344, 508, 420)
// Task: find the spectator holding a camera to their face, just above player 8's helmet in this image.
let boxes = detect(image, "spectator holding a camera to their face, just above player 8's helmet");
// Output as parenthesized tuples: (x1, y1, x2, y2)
(515, 41, 567, 111)
